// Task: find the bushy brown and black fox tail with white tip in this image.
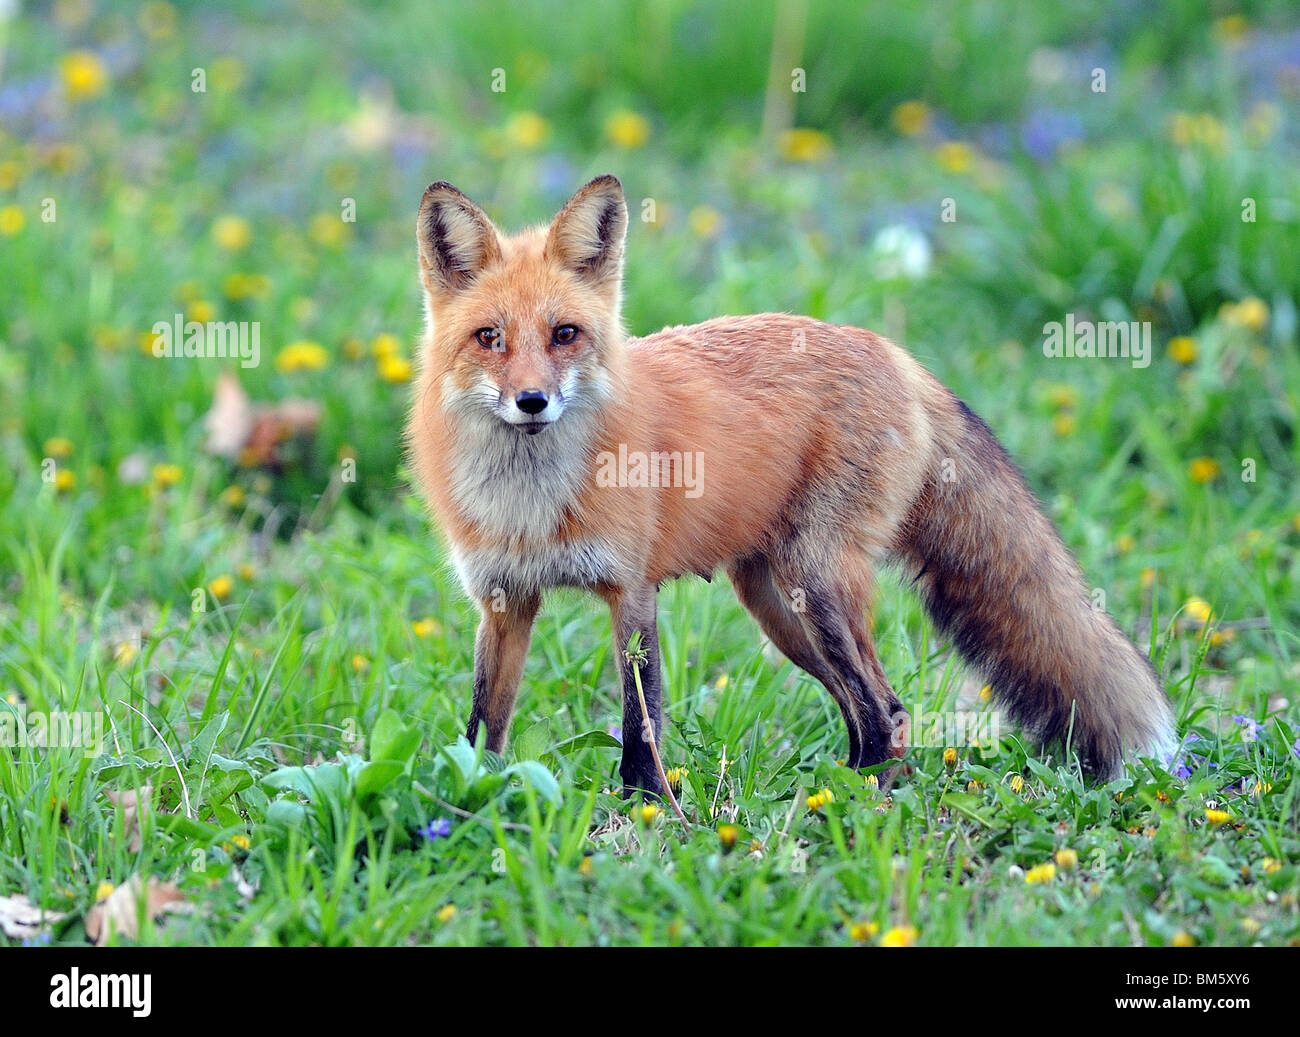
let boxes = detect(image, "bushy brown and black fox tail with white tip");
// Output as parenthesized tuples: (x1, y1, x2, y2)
(898, 398, 1177, 777)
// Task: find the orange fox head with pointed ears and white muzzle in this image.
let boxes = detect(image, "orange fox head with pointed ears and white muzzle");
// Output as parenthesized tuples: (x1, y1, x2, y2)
(416, 175, 628, 435)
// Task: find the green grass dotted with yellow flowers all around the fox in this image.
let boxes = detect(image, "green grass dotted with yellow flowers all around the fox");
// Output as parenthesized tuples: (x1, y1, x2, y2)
(0, 3, 1300, 945)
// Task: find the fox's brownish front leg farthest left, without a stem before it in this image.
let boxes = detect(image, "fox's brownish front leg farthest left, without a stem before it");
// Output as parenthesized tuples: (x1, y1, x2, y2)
(465, 594, 541, 752)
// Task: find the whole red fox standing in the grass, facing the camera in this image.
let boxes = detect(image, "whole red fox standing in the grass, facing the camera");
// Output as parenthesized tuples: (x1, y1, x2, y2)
(407, 175, 1175, 795)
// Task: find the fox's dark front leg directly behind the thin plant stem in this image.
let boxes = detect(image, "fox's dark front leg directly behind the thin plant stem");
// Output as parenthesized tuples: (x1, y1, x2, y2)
(605, 583, 663, 799)
